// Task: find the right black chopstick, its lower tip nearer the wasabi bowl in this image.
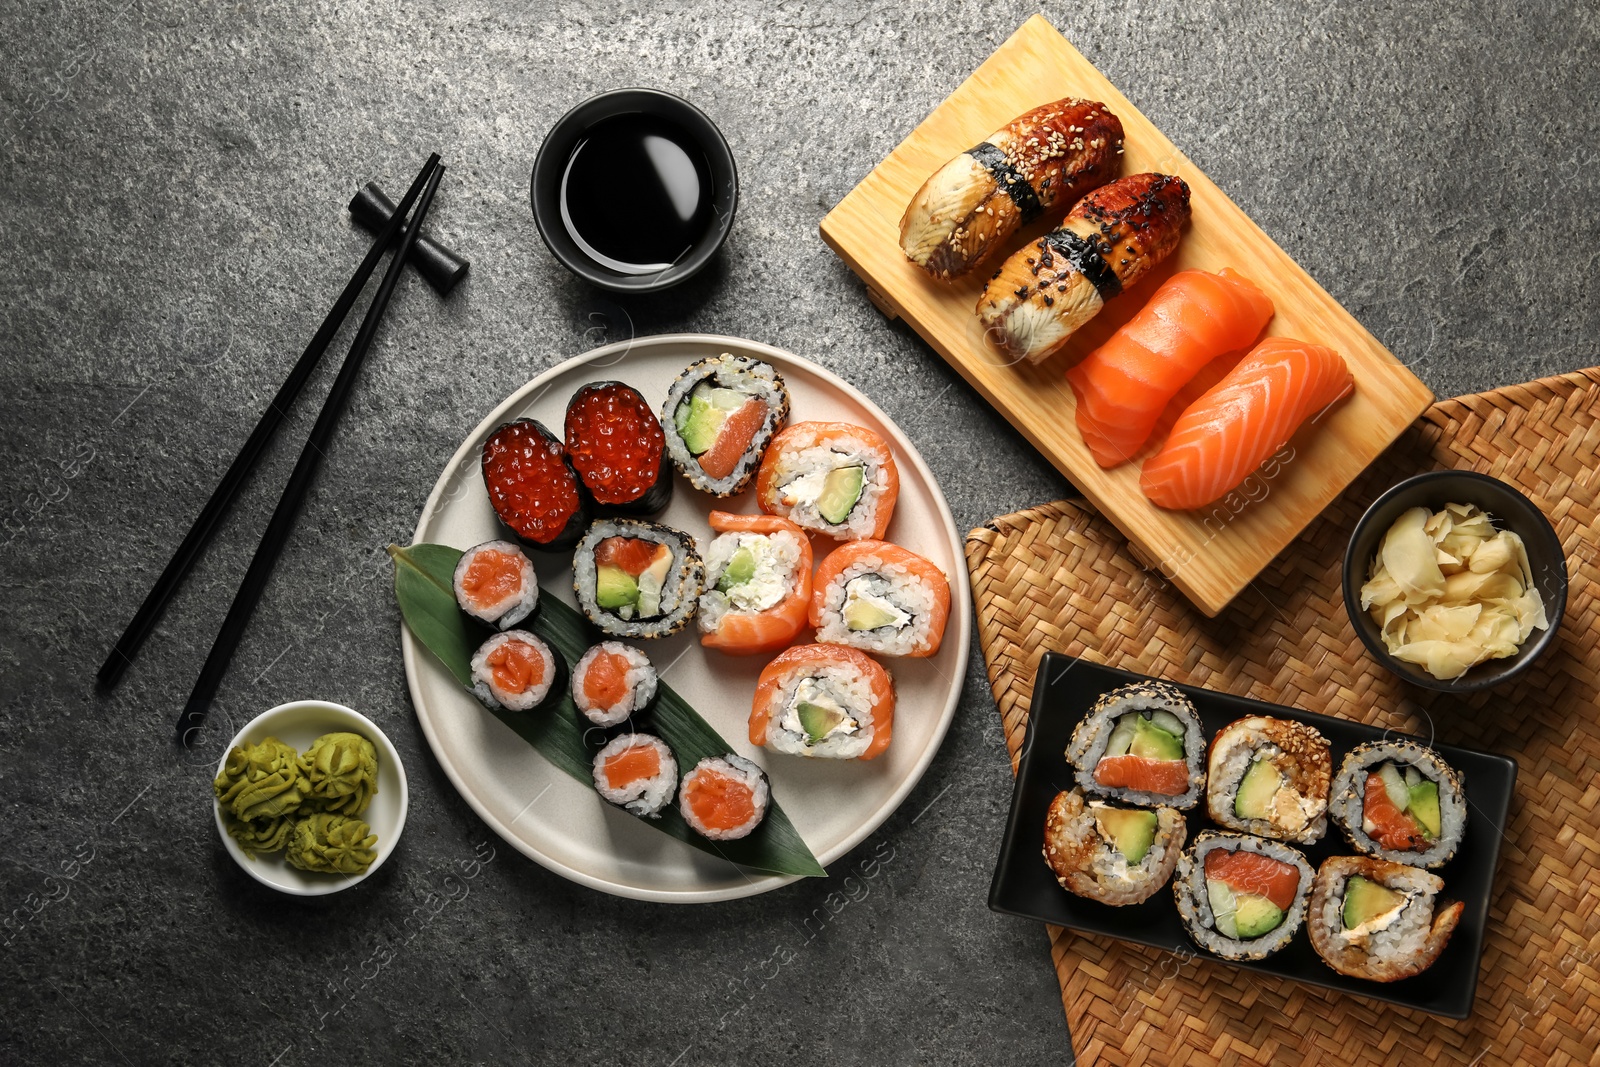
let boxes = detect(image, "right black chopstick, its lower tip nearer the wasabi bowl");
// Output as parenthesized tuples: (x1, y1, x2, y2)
(178, 155, 445, 747)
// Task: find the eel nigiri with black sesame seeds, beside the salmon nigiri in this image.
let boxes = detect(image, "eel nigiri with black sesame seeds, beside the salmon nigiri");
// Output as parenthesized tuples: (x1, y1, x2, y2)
(978, 174, 1189, 363)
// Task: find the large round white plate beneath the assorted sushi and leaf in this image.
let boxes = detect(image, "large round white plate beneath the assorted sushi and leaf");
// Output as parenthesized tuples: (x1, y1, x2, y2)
(400, 334, 973, 904)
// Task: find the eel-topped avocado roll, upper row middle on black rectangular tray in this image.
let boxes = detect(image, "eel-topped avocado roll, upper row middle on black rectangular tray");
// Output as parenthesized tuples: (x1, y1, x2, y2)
(1206, 715, 1333, 845)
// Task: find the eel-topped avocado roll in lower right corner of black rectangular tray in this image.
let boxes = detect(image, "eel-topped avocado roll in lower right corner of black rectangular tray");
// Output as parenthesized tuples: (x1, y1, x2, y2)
(1310, 856, 1467, 982)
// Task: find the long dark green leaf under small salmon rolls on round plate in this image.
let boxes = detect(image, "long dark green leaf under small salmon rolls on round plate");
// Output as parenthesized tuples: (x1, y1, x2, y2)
(389, 544, 827, 878)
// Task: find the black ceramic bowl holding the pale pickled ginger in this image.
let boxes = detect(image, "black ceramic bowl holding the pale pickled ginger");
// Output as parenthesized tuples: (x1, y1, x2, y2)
(1344, 470, 1566, 693)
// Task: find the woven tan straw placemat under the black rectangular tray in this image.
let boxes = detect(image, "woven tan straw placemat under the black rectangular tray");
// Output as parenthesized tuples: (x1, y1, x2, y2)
(966, 370, 1600, 1067)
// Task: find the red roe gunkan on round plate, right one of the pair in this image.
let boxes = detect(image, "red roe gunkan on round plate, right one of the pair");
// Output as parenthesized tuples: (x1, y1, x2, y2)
(566, 382, 672, 515)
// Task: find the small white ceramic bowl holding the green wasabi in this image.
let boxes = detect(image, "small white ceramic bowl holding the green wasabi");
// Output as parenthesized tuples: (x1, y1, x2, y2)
(210, 701, 408, 896)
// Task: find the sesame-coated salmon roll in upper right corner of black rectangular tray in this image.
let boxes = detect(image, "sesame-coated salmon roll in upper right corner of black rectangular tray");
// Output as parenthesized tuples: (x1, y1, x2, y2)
(1328, 741, 1467, 867)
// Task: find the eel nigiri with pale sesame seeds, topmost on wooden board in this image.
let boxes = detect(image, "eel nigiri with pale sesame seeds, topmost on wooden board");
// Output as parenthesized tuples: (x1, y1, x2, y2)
(901, 99, 1122, 278)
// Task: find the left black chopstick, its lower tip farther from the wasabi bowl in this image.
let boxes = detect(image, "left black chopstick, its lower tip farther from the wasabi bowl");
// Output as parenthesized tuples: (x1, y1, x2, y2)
(94, 154, 438, 688)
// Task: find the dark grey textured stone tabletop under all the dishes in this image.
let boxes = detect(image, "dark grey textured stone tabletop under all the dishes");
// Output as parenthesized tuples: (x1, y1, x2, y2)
(0, 0, 1600, 1067)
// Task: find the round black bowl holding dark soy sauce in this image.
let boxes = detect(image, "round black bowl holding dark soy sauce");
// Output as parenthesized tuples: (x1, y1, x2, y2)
(528, 88, 739, 293)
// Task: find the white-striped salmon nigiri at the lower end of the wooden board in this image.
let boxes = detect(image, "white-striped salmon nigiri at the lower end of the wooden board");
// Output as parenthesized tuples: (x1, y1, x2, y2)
(1139, 338, 1354, 510)
